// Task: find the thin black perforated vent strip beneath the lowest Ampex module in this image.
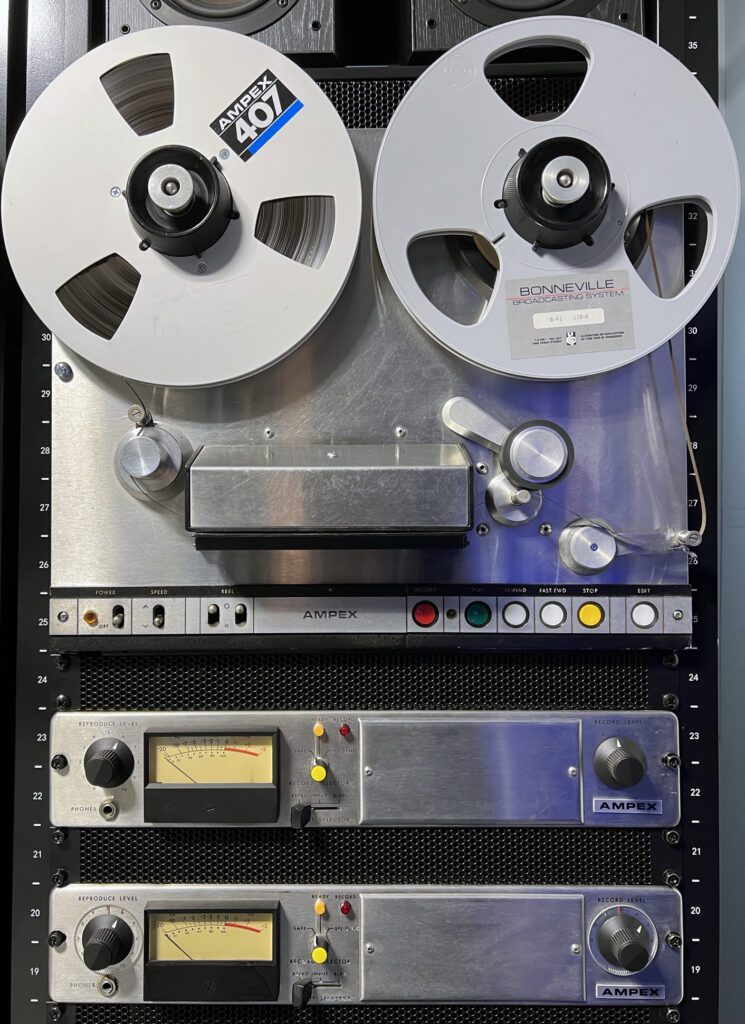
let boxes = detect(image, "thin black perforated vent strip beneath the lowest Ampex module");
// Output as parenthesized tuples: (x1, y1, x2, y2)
(76, 1007, 659, 1024)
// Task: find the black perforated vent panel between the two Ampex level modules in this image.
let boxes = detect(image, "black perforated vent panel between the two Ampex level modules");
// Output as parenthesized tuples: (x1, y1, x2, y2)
(80, 828, 652, 886)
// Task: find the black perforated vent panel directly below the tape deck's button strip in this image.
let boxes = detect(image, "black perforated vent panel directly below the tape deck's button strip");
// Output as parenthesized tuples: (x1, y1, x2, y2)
(81, 651, 648, 711)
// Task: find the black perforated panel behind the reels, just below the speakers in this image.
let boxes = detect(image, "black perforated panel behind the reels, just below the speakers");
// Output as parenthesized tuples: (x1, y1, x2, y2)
(318, 75, 582, 128)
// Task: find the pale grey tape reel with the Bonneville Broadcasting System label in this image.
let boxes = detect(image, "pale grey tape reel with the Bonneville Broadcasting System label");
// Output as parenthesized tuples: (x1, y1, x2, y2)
(374, 17, 740, 379)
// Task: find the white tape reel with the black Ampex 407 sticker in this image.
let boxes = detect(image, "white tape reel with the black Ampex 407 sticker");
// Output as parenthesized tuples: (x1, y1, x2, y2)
(2, 27, 361, 387)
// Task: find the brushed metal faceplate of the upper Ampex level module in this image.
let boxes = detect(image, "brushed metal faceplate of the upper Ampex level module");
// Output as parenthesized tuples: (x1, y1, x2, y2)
(50, 711, 680, 828)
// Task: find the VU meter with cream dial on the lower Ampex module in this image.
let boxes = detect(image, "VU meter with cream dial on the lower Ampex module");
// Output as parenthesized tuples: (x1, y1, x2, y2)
(144, 905, 279, 1002)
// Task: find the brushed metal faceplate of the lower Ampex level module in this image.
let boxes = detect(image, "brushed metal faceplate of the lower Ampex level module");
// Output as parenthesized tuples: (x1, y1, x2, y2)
(49, 885, 683, 1006)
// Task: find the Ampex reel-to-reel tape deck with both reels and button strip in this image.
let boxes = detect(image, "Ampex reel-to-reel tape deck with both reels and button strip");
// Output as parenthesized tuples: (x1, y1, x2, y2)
(3, 17, 739, 646)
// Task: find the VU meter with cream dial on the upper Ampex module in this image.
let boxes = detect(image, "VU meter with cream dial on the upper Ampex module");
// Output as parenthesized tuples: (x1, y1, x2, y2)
(144, 730, 279, 824)
